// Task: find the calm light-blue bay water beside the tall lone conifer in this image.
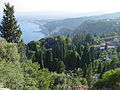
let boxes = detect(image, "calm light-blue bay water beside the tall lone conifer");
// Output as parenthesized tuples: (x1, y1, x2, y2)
(19, 21, 45, 43)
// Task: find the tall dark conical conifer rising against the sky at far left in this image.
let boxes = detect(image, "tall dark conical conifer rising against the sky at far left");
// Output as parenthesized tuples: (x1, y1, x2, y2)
(0, 3, 22, 43)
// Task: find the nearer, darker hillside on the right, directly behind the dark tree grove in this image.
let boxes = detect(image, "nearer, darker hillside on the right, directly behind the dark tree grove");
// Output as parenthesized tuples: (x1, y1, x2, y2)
(71, 19, 120, 34)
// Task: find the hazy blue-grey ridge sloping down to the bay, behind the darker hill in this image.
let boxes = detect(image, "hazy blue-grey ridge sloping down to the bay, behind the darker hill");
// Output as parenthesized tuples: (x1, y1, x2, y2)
(43, 12, 120, 35)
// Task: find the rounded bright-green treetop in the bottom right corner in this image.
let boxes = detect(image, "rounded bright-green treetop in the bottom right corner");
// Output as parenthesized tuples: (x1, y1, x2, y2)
(94, 68, 120, 90)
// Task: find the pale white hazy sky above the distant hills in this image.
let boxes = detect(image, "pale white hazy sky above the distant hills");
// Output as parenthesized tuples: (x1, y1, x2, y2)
(0, 0, 120, 13)
